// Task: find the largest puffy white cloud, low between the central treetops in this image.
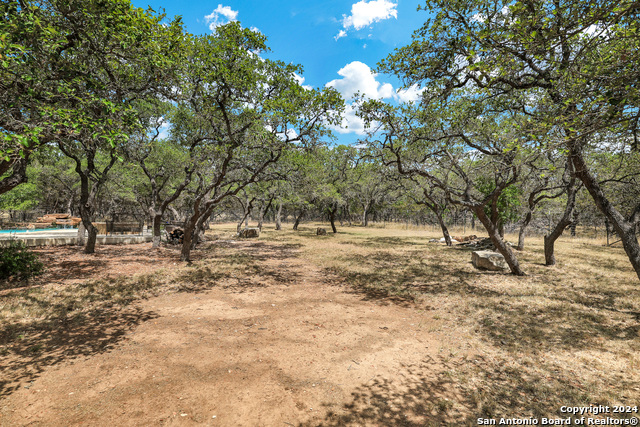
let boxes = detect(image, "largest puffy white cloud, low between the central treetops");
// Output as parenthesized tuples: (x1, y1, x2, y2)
(326, 61, 393, 99)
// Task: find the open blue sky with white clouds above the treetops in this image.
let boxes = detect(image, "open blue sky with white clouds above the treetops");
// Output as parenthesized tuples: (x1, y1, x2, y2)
(133, 0, 427, 144)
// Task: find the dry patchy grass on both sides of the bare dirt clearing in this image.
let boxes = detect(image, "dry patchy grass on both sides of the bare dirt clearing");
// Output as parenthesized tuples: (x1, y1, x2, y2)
(0, 225, 640, 424)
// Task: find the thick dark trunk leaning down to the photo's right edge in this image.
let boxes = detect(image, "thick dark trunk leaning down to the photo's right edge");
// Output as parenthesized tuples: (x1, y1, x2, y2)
(571, 146, 640, 279)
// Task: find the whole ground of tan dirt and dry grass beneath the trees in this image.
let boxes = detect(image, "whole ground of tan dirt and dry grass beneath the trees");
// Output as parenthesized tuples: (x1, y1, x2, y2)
(0, 224, 640, 427)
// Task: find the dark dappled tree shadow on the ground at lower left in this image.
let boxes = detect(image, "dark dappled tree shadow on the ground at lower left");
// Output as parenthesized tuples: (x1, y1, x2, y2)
(0, 306, 157, 398)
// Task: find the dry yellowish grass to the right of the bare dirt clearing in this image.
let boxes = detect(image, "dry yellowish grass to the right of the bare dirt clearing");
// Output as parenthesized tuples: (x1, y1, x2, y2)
(258, 227, 640, 422)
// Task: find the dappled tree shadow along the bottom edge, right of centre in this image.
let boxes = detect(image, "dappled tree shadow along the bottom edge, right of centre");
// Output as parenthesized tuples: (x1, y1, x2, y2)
(299, 355, 634, 427)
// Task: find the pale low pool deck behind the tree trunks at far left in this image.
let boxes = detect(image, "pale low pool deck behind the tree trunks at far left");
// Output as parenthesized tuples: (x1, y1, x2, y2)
(0, 229, 152, 247)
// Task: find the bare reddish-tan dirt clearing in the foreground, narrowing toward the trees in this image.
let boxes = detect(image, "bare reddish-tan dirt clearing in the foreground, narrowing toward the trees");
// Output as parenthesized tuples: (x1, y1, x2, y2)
(0, 242, 470, 426)
